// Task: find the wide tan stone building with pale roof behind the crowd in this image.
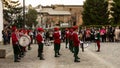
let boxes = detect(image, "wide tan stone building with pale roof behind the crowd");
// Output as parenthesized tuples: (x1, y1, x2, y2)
(37, 5, 83, 28)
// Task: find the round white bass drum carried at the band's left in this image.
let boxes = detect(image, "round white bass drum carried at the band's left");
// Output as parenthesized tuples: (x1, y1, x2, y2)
(19, 35, 31, 47)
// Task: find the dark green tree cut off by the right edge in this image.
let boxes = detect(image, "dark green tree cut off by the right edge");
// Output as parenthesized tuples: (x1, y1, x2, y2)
(110, 0, 120, 24)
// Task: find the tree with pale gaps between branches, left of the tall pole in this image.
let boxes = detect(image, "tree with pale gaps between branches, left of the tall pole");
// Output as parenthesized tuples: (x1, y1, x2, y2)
(3, 0, 22, 26)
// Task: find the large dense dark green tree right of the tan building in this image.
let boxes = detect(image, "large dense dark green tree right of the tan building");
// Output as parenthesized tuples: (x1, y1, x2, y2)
(82, 0, 109, 25)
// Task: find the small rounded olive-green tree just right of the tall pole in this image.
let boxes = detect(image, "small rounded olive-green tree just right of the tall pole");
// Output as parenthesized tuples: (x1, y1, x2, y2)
(25, 8, 37, 27)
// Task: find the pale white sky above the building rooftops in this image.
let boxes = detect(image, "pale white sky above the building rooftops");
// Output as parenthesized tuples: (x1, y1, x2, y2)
(19, 0, 85, 7)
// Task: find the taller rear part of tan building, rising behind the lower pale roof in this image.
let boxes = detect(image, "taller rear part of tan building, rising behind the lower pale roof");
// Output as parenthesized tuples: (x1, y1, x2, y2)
(52, 5, 83, 25)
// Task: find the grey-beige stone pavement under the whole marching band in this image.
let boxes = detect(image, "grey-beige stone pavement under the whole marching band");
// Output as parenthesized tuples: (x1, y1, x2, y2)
(0, 43, 120, 68)
